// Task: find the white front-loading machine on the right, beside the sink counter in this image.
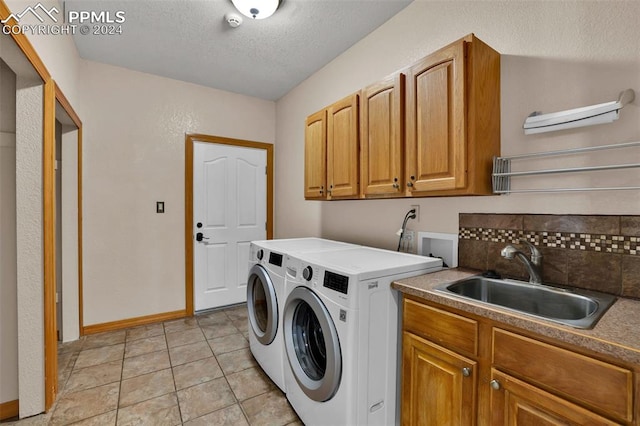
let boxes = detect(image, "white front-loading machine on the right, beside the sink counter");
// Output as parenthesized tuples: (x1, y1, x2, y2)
(283, 247, 442, 426)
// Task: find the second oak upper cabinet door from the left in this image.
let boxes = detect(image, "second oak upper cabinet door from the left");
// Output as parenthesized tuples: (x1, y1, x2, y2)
(327, 94, 359, 198)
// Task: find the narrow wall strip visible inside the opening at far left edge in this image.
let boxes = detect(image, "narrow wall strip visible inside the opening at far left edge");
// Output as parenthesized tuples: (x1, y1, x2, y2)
(0, 60, 18, 404)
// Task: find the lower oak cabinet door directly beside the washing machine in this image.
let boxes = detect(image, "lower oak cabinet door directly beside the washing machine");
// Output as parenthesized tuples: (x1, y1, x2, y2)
(402, 332, 476, 426)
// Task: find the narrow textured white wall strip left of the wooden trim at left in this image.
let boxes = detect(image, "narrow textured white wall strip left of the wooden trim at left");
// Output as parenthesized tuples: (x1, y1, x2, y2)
(16, 76, 44, 417)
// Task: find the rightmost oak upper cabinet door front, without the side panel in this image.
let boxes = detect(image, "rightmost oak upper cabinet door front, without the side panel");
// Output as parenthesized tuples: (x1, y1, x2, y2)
(406, 41, 467, 195)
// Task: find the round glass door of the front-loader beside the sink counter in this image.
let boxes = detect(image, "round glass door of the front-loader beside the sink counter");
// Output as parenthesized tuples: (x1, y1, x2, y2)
(284, 287, 342, 402)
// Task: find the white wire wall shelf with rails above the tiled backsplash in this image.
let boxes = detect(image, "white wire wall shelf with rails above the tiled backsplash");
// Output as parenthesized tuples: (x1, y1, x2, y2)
(492, 141, 640, 194)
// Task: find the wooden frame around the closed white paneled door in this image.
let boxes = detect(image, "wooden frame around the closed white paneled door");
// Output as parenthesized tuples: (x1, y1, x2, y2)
(184, 133, 274, 316)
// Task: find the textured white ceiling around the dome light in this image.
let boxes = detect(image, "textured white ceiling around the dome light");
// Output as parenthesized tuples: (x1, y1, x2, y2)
(64, 0, 412, 100)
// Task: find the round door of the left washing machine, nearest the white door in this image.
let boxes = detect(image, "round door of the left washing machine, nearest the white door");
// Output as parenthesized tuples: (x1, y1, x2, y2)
(247, 264, 278, 345)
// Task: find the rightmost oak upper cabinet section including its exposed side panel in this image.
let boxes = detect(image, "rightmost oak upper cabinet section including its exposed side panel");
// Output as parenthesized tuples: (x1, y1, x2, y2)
(405, 34, 500, 196)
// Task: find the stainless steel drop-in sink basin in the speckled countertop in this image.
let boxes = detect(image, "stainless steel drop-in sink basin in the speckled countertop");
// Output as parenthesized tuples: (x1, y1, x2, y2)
(436, 276, 616, 328)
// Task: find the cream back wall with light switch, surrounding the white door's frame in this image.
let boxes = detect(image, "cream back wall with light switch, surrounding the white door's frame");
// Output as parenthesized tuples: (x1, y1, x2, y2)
(79, 62, 275, 325)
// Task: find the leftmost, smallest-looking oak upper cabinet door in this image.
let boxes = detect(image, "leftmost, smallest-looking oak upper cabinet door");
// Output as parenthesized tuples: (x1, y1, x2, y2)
(304, 110, 327, 199)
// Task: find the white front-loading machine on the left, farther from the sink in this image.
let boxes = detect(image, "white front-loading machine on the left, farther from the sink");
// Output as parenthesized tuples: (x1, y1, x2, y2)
(247, 238, 358, 392)
